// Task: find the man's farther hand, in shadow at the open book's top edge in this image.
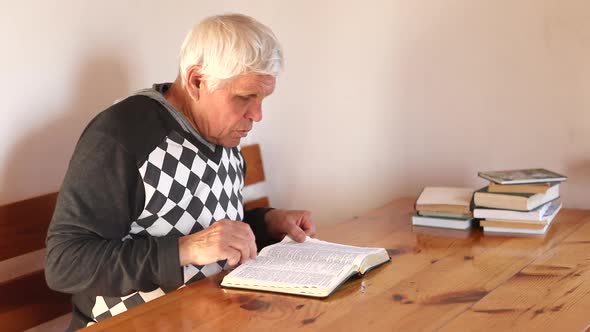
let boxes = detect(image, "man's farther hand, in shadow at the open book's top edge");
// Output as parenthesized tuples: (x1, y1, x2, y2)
(264, 209, 315, 242)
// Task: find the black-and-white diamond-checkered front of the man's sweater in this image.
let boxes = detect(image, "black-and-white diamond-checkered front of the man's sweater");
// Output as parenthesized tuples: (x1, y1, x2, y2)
(92, 132, 244, 321)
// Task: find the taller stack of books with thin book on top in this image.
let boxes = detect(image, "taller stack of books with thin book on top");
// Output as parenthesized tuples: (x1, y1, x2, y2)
(473, 169, 567, 235)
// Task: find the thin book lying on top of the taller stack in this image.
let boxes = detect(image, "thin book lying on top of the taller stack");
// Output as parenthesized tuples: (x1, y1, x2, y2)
(477, 168, 567, 184)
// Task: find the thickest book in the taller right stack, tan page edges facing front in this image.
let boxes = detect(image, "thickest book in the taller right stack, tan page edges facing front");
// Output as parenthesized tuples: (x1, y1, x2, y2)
(473, 185, 559, 211)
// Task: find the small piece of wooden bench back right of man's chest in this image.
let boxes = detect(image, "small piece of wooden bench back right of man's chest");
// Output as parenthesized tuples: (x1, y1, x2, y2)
(242, 144, 270, 210)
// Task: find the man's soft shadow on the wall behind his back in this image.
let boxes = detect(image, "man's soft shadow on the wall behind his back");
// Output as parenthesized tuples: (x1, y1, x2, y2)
(0, 55, 129, 204)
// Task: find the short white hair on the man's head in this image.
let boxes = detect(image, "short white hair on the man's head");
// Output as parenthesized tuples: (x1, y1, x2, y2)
(179, 14, 283, 91)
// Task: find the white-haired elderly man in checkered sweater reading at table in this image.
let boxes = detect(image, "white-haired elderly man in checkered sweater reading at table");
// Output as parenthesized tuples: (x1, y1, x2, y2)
(46, 15, 315, 330)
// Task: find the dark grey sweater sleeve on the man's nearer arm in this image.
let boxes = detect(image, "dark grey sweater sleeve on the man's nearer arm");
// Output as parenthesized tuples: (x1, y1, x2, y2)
(45, 131, 182, 296)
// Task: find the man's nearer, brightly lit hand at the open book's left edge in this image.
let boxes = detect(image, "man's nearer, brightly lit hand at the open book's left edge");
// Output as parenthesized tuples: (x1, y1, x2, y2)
(178, 219, 257, 266)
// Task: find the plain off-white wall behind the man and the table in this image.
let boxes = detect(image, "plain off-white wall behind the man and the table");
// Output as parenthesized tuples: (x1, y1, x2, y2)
(0, 0, 590, 223)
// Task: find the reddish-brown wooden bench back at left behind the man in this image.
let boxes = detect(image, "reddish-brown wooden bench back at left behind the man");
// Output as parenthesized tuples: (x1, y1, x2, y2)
(0, 193, 72, 331)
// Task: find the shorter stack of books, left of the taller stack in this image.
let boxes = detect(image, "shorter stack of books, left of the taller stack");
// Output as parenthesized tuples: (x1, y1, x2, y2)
(412, 187, 473, 230)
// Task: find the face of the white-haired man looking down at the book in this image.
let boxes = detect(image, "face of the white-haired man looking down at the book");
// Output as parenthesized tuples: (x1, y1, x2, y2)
(191, 74, 276, 147)
